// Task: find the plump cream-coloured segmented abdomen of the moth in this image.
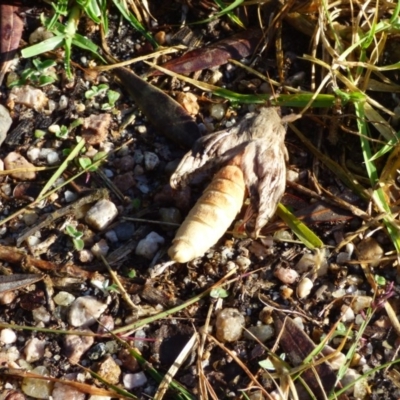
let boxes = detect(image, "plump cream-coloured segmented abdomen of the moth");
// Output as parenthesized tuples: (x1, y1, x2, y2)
(168, 165, 245, 263)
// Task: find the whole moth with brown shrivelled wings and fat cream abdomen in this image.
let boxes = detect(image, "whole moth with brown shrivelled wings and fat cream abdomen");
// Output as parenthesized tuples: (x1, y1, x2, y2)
(168, 107, 292, 263)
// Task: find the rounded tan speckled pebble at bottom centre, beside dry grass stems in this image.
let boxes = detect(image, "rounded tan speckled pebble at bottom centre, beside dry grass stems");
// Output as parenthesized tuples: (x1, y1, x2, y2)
(215, 308, 245, 342)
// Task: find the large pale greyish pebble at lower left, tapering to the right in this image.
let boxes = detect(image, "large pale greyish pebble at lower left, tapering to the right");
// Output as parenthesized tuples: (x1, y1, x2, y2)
(68, 296, 107, 328)
